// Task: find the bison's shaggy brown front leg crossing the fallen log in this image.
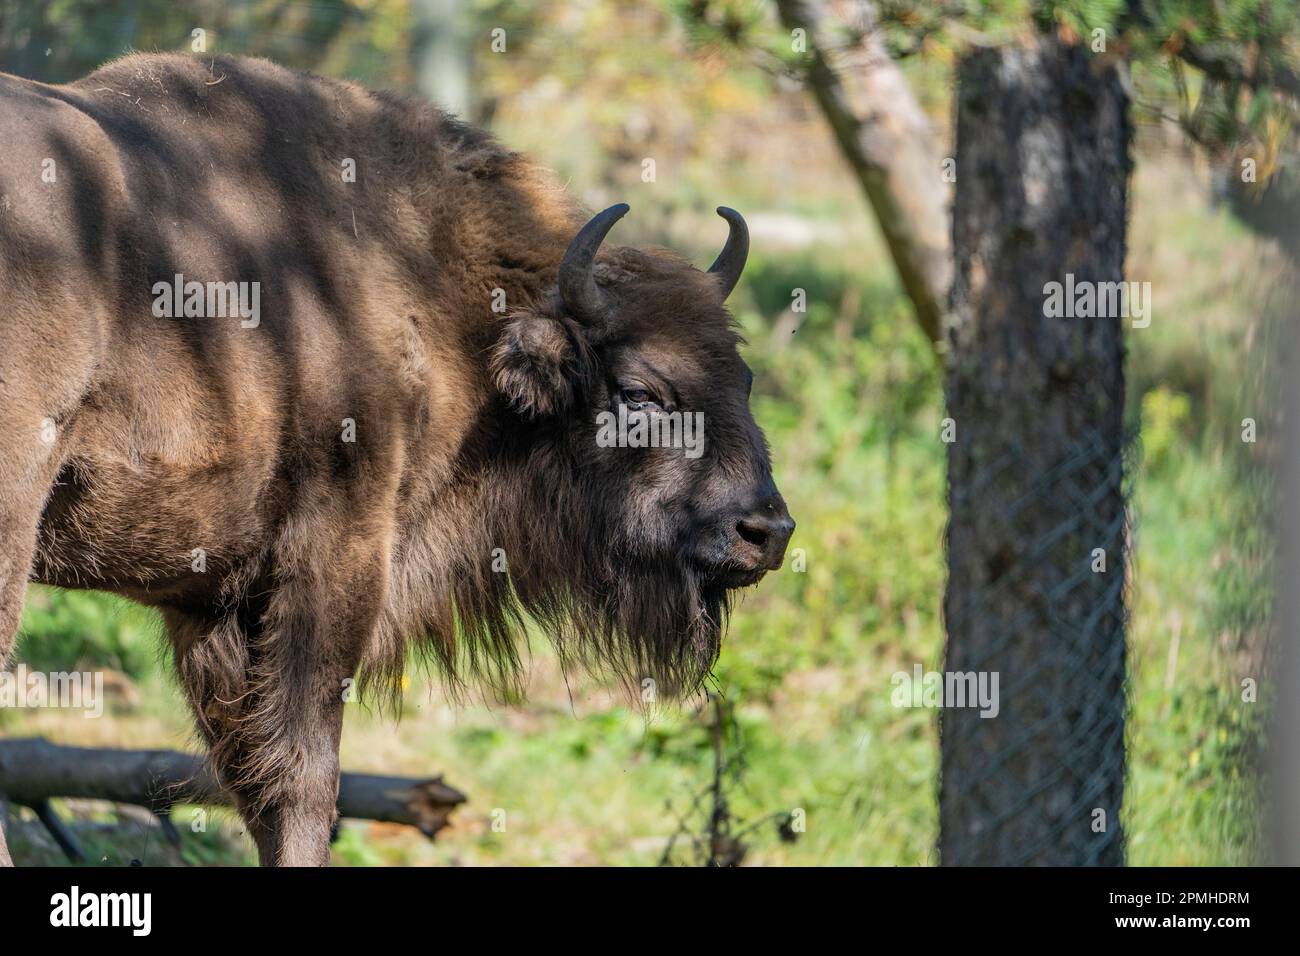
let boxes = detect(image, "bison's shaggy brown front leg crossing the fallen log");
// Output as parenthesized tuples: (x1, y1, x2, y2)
(173, 527, 387, 866)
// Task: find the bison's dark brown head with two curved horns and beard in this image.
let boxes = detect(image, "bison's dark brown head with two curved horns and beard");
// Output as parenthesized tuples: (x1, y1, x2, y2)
(493, 204, 794, 689)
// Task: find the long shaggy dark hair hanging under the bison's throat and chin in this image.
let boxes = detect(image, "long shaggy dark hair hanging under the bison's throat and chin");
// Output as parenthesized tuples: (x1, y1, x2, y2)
(363, 416, 727, 698)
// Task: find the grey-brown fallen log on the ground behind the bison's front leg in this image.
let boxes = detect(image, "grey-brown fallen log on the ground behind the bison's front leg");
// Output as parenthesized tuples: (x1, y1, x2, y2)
(0, 737, 465, 849)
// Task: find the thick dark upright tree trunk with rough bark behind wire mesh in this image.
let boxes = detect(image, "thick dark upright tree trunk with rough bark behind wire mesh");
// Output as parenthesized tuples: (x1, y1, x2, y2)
(940, 38, 1133, 865)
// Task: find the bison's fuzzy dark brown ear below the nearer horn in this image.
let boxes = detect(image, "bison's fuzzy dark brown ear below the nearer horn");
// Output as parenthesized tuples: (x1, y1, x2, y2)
(491, 315, 580, 416)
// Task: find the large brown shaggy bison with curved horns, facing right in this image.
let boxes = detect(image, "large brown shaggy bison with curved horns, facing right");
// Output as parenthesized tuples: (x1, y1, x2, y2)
(0, 55, 794, 865)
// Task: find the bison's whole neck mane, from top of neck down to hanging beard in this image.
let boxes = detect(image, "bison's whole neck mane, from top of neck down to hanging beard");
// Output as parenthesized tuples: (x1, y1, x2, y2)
(243, 74, 725, 700)
